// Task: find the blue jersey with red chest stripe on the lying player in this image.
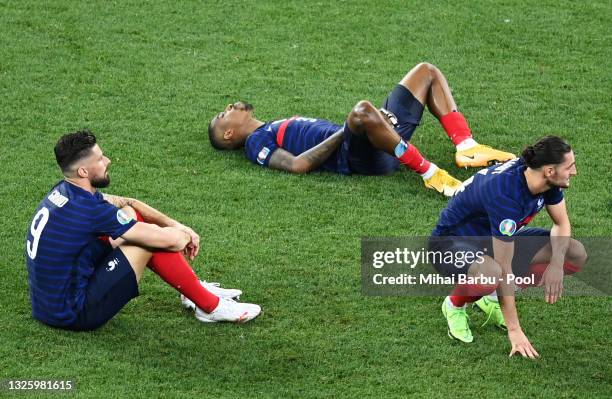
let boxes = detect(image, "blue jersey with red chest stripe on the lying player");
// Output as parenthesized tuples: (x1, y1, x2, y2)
(244, 117, 350, 174)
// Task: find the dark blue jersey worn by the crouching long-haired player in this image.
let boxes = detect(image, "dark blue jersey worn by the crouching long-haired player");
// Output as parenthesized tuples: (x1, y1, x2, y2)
(432, 159, 563, 237)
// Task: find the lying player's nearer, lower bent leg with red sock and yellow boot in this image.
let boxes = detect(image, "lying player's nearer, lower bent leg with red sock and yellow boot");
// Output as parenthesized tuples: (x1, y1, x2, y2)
(347, 101, 461, 196)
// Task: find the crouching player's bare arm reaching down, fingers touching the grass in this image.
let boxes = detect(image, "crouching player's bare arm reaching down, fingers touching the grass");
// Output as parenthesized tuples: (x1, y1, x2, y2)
(493, 238, 540, 359)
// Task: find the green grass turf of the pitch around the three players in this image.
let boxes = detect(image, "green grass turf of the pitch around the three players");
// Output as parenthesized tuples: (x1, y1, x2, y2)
(0, 0, 612, 398)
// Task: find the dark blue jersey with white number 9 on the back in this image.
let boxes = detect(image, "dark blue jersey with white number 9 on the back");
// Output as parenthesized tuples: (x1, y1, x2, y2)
(26, 181, 136, 326)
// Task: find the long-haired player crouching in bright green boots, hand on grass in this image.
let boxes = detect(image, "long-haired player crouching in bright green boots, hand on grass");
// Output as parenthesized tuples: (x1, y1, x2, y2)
(429, 136, 587, 358)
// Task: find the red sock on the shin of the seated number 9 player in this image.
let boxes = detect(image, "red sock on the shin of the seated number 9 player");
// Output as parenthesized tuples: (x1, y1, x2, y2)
(136, 208, 219, 313)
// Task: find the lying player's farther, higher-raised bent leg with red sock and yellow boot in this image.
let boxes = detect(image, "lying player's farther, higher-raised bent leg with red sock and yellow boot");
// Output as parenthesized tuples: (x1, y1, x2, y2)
(400, 62, 515, 167)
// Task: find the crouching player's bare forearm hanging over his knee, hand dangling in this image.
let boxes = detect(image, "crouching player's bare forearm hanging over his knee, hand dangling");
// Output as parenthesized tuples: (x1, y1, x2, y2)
(539, 200, 572, 304)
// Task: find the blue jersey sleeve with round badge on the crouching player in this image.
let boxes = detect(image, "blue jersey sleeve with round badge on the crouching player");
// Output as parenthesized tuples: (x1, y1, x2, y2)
(485, 195, 522, 241)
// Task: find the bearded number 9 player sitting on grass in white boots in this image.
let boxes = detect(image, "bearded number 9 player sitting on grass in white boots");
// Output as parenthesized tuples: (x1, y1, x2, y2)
(26, 130, 261, 331)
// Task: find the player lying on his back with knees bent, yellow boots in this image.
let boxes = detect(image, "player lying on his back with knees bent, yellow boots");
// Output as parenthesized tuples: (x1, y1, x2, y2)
(208, 63, 514, 196)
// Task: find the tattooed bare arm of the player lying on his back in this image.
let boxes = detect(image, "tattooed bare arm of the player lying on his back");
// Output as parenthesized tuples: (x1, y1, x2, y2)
(270, 129, 344, 173)
